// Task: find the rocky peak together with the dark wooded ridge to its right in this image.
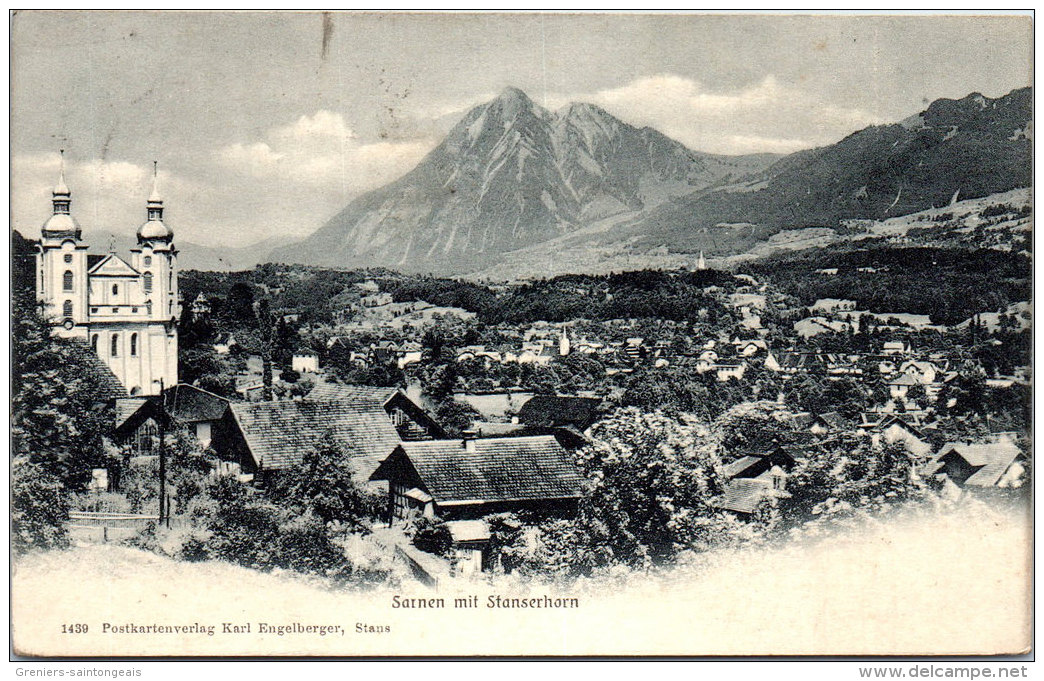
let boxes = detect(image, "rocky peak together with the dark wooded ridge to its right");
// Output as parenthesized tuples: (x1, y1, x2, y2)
(270, 88, 1033, 279)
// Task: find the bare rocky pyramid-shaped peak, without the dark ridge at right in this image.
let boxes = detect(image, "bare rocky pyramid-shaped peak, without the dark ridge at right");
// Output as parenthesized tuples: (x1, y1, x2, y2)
(272, 88, 777, 274)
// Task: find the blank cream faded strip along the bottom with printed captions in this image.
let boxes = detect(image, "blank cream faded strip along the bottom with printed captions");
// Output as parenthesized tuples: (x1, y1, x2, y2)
(11, 503, 1031, 656)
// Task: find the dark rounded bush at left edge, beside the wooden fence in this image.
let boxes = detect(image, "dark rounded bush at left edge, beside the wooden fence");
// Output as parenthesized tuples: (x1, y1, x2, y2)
(10, 456, 69, 554)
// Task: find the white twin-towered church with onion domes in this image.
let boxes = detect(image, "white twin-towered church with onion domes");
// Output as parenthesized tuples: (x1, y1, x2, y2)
(37, 156, 181, 396)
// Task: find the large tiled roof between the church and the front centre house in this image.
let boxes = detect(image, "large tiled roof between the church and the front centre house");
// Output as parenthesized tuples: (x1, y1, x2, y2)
(229, 400, 399, 476)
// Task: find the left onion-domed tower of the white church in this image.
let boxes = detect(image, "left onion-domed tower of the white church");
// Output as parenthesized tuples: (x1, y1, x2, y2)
(37, 150, 89, 339)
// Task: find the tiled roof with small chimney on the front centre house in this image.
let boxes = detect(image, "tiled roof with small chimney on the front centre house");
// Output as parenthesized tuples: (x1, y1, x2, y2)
(371, 436, 582, 506)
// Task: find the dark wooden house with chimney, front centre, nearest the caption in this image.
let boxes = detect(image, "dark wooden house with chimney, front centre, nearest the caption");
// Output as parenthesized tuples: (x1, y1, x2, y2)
(370, 436, 583, 524)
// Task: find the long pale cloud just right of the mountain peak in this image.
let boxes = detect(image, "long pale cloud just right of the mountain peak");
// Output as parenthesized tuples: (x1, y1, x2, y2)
(548, 73, 880, 154)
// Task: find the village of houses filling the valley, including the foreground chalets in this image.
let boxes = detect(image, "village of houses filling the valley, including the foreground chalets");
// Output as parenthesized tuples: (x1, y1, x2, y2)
(26, 235, 1029, 584)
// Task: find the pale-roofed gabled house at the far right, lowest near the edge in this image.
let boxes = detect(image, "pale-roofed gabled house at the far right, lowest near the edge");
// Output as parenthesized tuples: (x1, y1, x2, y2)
(925, 439, 1026, 488)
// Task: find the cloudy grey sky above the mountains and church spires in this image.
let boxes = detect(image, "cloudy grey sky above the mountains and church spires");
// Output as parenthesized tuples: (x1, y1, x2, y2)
(10, 11, 1033, 246)
